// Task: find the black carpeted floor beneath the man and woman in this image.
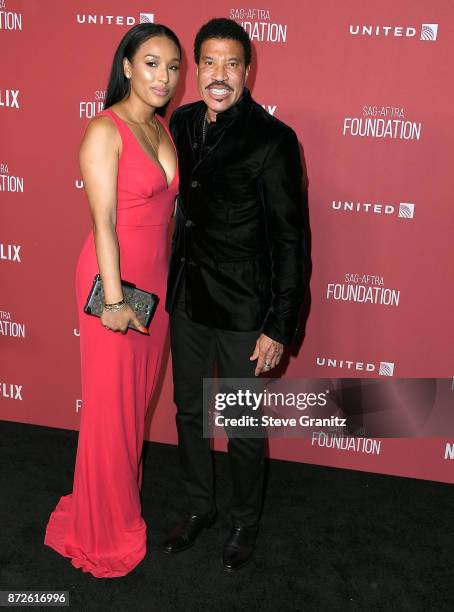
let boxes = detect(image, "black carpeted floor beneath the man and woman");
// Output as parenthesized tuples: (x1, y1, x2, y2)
(0, 422, 454, 612)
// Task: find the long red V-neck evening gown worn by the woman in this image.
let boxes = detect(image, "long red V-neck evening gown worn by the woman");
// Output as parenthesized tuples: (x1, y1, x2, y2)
(44, 109, 178, 578)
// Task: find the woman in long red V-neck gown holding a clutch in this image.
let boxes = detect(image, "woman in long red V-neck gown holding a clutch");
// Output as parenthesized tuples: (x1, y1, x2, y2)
(45, 24, 181, 578)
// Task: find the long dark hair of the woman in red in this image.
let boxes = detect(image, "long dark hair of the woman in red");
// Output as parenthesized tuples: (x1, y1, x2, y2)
(104, 23, 181, 115)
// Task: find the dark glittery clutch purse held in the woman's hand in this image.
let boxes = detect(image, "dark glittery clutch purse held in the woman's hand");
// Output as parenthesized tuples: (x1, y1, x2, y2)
(84, 274, 159, 331)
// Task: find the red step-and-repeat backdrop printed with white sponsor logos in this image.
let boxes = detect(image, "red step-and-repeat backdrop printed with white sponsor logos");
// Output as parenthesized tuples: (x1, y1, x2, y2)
(0, 0, 454, 482)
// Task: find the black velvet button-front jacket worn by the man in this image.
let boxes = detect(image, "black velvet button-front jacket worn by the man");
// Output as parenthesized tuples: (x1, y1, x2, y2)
(166, 89, 307, 344)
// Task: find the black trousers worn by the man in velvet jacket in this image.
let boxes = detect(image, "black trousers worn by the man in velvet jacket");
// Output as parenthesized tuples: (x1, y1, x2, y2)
(170, 289, 265, 526)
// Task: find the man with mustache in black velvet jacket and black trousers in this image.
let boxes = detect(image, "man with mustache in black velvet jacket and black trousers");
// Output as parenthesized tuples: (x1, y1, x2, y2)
(164, 19, 307, 571)
